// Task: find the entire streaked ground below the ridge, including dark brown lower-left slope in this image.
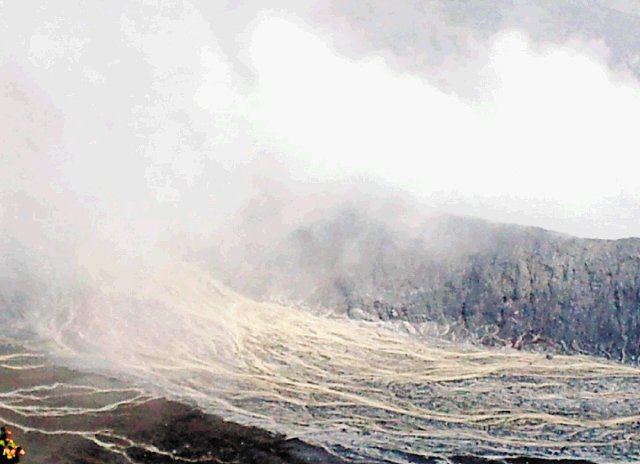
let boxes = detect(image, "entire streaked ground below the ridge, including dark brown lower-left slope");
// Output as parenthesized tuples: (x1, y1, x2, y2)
(0, 266, 640, 464)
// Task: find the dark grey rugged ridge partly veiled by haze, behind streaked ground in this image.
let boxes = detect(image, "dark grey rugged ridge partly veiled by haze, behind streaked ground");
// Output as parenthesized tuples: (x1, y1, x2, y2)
(228, 210, 640, 362)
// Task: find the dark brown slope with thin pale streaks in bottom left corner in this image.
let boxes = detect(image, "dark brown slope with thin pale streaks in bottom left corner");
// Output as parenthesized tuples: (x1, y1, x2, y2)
(0, 343, 608, 464)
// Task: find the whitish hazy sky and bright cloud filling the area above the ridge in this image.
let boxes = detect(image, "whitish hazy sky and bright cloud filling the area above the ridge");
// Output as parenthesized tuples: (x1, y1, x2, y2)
(0, 1, 640, 252)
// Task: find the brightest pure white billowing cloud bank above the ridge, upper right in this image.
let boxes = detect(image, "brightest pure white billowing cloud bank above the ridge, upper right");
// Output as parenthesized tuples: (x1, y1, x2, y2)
(251, 18, 640, 236)
